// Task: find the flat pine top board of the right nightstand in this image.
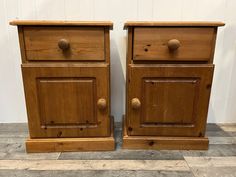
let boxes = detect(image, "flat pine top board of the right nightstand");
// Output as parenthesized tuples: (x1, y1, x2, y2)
(124, 21, 225, 29)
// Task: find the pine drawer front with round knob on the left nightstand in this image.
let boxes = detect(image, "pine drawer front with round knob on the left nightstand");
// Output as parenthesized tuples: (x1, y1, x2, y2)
(24, 27, 105, 61)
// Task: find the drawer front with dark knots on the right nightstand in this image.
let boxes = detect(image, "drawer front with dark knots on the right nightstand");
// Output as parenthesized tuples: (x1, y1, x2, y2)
(133, 27, 215, 61)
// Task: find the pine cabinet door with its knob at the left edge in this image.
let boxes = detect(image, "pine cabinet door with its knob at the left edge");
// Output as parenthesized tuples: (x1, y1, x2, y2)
(127, 65, 214, 136)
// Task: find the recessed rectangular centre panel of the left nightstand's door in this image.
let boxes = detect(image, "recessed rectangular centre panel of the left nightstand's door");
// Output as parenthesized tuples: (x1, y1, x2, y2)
(37, 77, 97, 126)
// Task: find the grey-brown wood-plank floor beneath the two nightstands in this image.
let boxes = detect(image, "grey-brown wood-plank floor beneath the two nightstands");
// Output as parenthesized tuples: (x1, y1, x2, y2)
(0, 123, 236, 177)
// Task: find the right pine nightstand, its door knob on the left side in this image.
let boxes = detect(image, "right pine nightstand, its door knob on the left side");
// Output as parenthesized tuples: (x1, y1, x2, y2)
(123, 22, 224, 149)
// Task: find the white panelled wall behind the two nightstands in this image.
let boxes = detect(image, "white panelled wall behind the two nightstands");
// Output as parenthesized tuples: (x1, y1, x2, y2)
(0, 0, 236, 123)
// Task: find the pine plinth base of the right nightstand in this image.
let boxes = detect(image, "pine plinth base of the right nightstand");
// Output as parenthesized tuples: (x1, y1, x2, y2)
(122, 116, 209, 150)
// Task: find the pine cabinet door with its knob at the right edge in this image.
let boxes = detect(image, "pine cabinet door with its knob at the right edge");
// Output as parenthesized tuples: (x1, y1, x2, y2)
(22, 64, 110, 138)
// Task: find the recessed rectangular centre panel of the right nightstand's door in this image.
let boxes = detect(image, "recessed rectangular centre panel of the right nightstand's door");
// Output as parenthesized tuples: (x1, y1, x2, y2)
(141, 78, 199, 125)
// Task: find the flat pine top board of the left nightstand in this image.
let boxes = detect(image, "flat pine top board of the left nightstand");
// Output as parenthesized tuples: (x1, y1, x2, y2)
(9, 20, 113, 29)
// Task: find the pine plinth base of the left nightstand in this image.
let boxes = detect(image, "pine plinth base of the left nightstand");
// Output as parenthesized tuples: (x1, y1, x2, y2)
(25, 117, 115, 153)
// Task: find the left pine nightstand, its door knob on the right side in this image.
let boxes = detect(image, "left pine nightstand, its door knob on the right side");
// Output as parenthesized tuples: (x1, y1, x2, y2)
(10, 21, 115, 152)
